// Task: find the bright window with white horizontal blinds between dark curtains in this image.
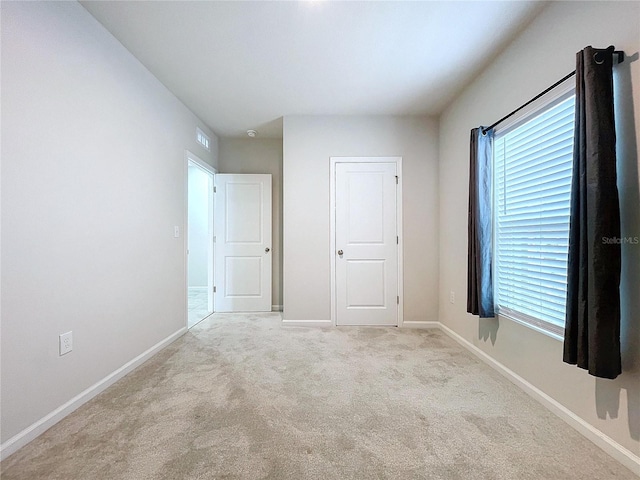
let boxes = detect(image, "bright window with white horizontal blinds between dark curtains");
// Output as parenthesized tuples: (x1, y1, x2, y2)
(493, 94, 575, 336)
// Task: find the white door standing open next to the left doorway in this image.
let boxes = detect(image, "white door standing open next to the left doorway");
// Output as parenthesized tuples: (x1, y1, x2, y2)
(214, 174, 272, 312)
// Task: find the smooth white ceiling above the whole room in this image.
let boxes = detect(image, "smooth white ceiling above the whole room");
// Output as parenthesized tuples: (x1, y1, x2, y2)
(81, 0, 544, 137)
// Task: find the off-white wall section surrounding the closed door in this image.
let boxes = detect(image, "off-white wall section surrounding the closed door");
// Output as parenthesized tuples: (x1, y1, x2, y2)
(283, 116, 438, 322)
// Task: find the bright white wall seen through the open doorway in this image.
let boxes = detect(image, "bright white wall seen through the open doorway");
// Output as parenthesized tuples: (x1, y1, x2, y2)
(187, 165, 209, 287)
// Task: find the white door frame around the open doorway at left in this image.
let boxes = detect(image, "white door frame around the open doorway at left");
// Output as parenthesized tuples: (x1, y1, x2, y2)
(182, 149, 218, 328)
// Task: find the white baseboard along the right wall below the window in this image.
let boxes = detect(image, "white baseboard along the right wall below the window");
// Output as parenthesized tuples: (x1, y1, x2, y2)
(438, 322, 640, 476)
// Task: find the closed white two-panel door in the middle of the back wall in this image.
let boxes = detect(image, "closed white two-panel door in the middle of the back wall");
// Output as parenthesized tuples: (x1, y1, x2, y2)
(335, 163, 398, 325)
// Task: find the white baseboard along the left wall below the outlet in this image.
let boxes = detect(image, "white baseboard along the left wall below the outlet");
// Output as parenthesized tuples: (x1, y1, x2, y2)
(0, 327, 188, 460)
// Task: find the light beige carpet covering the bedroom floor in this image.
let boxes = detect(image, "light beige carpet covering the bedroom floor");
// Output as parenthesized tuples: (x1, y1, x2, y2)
(1, 314, 637, 480)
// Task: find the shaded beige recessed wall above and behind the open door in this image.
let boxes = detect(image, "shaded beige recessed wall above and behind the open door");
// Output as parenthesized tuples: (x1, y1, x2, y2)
(218, 138, 282, 308)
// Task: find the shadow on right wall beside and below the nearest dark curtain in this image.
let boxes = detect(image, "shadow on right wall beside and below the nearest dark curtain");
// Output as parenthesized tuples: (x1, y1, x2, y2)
(596, 52, 640, 440)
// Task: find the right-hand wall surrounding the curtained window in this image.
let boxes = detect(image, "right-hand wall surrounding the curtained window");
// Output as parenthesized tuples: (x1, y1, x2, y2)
(440, 2, 640, 455)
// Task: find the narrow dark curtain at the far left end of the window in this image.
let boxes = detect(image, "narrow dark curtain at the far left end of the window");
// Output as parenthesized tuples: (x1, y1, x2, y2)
(467, 127, 494, 318)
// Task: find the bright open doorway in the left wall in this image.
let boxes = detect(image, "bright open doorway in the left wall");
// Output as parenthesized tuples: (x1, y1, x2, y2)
(187, 152, 216, 328)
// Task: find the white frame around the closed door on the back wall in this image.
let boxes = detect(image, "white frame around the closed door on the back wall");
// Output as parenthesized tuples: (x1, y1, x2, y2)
(329, 157, 404, 327)
